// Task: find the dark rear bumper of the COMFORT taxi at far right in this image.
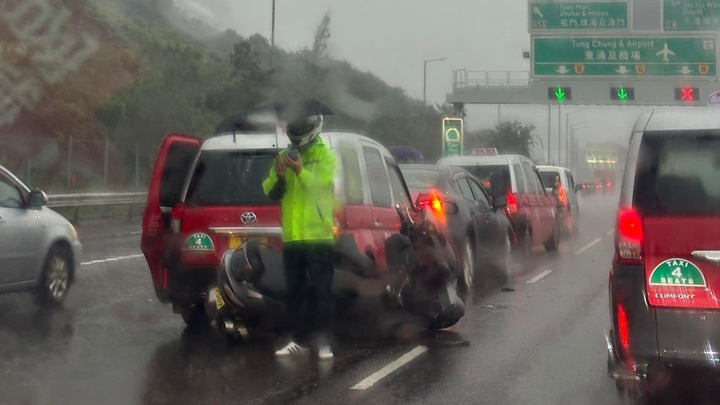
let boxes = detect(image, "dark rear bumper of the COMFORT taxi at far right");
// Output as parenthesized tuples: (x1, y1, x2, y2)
(607, 265, 720, 379)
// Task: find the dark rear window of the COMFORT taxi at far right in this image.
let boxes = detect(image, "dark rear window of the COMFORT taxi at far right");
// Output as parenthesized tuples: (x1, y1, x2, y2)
(633, 132, 720, 215)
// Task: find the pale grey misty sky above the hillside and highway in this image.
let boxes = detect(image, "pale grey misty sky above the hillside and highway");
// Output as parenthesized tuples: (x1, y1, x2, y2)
(176, 0, 660, 164)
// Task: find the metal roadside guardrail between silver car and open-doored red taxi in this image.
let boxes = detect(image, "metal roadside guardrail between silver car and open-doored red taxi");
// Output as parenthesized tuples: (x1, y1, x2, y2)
(47, 193, 147, 225)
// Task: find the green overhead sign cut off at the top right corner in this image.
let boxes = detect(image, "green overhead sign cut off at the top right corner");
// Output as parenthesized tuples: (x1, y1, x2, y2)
(663, 0, 720, 31)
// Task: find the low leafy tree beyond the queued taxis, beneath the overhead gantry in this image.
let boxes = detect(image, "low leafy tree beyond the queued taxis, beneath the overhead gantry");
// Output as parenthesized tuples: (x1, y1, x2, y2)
(465, 121, 535, 157)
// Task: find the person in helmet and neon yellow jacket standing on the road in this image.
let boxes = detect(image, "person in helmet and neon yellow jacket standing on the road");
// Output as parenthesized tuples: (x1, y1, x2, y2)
(263, 114, 337, 359)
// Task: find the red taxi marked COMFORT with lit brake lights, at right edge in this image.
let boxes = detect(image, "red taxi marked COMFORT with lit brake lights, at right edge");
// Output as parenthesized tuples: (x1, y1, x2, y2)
(607, 110, 720, 398)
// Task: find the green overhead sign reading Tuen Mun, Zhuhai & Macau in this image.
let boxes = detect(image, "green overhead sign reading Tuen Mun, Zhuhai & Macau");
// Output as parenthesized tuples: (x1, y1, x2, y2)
(529, 1, 628, 31)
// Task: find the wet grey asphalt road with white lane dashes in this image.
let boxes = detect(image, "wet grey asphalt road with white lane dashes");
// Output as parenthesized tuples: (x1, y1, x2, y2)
(0, 196, 700, 405)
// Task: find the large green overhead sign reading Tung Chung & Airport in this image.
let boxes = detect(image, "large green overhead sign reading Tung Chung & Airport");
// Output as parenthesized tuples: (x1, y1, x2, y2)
(532, 36, 720, 78)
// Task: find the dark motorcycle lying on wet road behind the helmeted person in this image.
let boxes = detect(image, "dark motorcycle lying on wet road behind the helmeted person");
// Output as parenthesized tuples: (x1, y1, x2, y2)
(211, 207, 465, 340)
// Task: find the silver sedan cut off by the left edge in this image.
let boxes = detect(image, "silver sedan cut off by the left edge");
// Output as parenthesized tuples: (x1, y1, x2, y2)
(0, 166, 82, 305)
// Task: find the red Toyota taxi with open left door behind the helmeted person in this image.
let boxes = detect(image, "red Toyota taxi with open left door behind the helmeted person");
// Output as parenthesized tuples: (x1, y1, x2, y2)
(141, 133, 412, 326)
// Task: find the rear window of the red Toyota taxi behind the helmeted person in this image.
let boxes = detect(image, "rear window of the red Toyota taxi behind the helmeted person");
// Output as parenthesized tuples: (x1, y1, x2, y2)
(186, 150, 276, 206)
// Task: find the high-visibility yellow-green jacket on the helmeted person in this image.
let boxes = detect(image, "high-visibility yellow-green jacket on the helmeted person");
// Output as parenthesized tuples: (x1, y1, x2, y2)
(263, 139, 337, 242)
